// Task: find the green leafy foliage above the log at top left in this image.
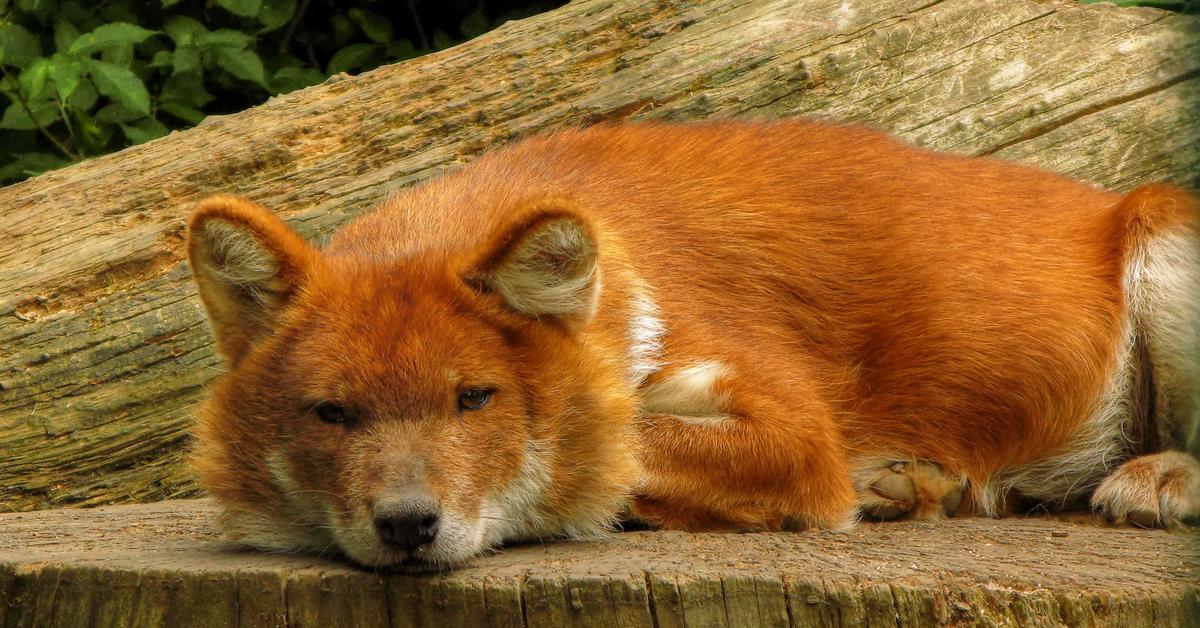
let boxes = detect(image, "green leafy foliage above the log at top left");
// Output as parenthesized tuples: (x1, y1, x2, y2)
(0, 0, 563, 185)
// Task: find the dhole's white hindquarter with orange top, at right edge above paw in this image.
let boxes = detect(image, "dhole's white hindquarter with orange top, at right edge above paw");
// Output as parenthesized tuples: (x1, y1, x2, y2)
(1118, 185, 1200, 455)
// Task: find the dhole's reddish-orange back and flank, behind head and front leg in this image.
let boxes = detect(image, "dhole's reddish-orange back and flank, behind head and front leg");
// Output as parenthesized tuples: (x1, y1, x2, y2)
(330, 122, 1152, 487)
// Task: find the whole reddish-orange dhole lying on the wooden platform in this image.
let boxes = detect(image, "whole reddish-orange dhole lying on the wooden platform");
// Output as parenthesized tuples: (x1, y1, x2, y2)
(188, 121, 1200, 570)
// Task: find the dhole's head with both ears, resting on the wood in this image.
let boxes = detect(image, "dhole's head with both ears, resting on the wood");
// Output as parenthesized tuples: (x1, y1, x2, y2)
(188, 197, 634, 569)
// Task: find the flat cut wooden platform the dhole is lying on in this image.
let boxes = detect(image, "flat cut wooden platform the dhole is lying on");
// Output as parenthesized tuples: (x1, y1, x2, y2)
(0, 500, 1200, 628)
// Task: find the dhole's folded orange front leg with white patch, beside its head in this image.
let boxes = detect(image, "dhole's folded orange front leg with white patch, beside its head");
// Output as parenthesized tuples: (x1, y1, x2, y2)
(632, 359, 854, 531)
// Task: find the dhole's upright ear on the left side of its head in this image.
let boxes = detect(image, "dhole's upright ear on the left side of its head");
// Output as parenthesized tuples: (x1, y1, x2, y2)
(187, 196, 317, 365)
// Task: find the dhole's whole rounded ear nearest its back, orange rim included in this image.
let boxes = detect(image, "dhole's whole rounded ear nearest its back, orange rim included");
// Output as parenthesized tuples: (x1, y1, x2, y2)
(467, 201, 600, 330)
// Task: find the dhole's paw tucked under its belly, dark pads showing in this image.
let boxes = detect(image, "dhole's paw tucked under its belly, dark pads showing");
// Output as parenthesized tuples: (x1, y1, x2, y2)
(857, 461, 964, 521)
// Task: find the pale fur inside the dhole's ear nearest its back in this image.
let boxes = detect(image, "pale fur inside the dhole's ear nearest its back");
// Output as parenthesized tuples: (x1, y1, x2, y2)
(484, 216, 600, 325)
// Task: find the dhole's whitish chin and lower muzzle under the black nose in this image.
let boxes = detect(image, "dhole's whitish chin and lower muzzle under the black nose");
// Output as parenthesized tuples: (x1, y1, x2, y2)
(331, 514, 487, 573)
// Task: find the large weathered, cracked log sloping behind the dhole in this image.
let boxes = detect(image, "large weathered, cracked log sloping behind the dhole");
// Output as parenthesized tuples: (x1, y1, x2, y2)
(0, 0, 1200, 510)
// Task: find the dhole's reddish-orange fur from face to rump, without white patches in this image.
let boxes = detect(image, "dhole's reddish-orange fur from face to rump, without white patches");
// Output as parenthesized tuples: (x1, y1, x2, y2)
(192, 121, 1198, 566)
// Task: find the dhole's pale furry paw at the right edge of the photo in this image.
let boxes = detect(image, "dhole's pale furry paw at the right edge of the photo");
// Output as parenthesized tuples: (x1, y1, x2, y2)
(1092, 451, 1200, 527)
